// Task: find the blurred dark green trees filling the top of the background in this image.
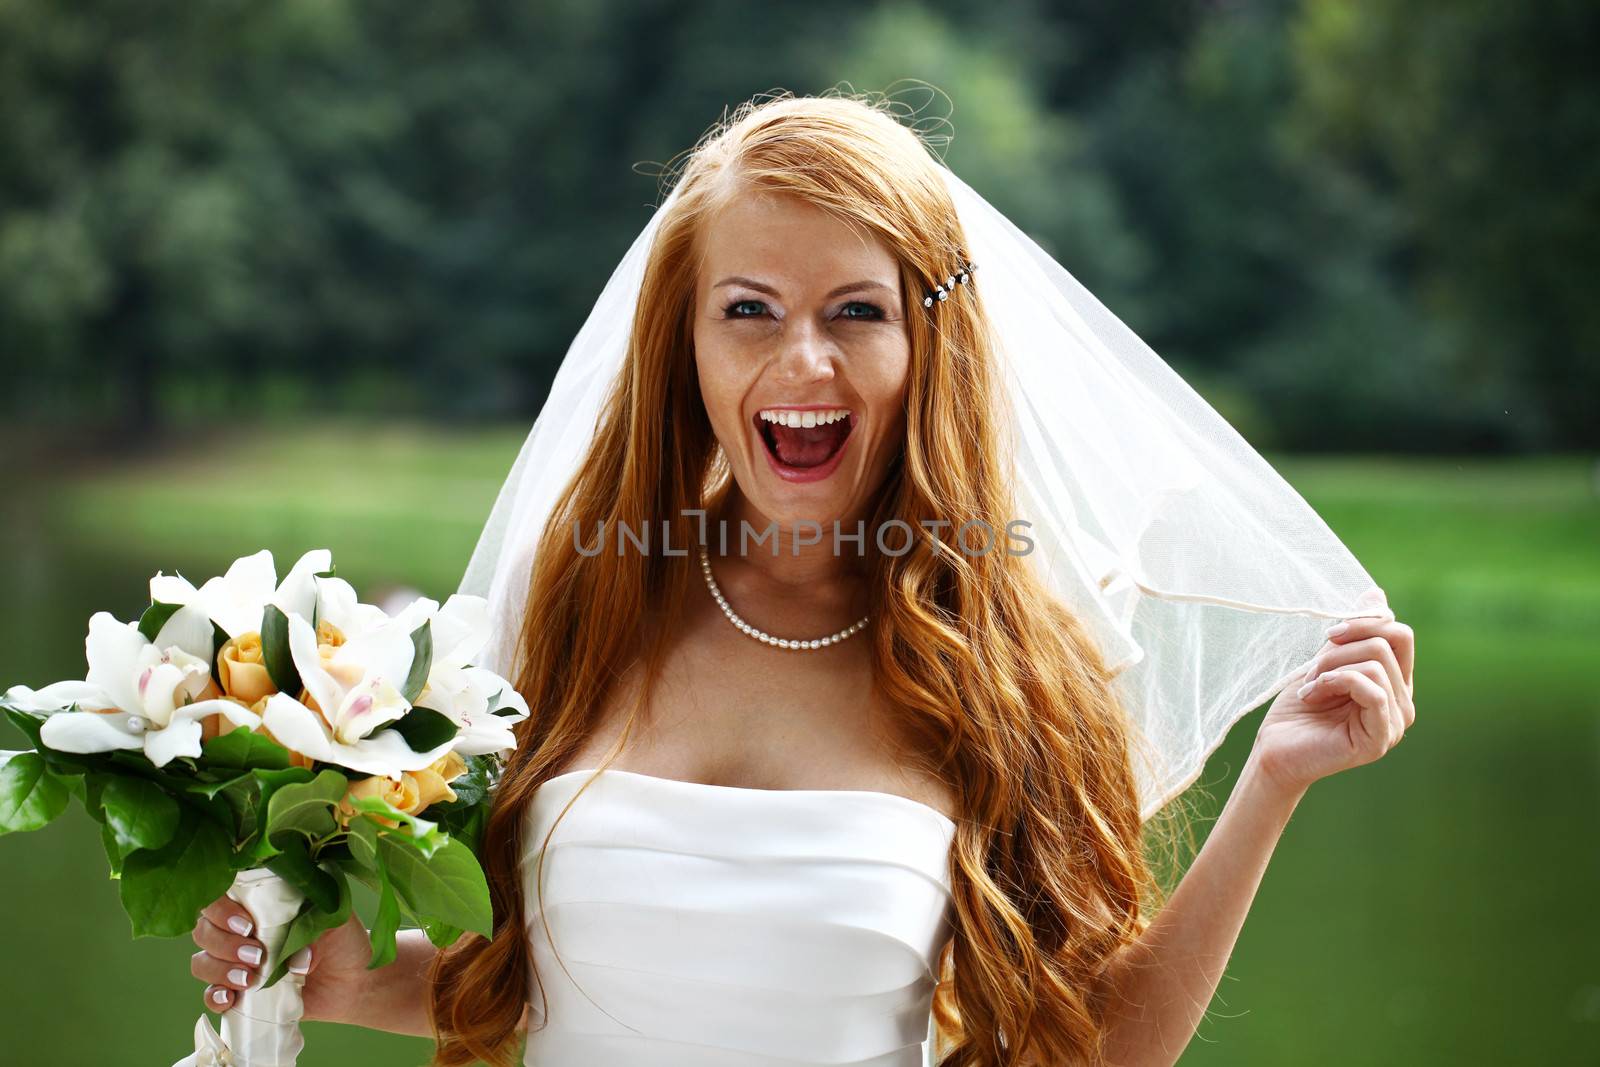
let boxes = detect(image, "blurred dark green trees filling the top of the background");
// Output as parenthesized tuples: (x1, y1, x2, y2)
(0, 0, 1600, 451)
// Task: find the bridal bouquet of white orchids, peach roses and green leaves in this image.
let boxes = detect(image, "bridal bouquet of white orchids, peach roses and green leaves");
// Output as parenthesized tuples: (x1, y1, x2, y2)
(0, 549, 528, 1067)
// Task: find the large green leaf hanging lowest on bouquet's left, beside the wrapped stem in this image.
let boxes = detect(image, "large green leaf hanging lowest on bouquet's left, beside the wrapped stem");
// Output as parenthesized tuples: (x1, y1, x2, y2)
(120, 808, 234, 937)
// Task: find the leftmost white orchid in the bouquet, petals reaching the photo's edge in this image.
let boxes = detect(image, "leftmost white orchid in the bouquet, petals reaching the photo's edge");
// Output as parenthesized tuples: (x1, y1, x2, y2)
(6, 608, 261, 766)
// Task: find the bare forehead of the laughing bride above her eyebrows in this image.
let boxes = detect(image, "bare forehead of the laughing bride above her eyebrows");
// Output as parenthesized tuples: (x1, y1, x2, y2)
(701, 190, 899, 286)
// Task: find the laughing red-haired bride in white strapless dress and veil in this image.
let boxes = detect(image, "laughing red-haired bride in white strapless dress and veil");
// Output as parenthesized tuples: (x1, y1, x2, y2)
(192, 94, 1414, 1067)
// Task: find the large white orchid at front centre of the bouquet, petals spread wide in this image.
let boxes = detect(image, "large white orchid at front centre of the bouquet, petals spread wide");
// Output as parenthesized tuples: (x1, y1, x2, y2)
(262, 597, 454, 779)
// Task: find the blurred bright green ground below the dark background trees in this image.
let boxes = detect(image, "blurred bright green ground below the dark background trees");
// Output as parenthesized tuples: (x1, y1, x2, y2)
(0, 421, 1600, 1067)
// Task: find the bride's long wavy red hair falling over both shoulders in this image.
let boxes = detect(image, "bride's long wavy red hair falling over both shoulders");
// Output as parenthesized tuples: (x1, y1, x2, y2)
(430, 93, 1190, 1067)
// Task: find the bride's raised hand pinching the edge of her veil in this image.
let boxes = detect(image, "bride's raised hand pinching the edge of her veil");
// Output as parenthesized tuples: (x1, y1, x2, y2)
(1250, 589, 1416, 792)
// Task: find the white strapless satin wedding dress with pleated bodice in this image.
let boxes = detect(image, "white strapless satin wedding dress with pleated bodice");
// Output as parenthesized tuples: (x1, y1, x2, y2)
(522, 768, 955, 1067)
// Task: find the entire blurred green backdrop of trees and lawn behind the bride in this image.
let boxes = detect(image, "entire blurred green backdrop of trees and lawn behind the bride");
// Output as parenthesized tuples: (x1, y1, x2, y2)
(0, 0, 1600, 1067)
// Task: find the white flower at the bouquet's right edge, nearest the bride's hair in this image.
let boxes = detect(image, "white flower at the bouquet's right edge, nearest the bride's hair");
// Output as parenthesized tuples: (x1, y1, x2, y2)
(418, 593, 528, 757)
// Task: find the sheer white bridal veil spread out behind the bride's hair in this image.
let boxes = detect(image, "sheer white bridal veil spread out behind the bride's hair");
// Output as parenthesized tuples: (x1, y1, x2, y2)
(461, 154, 1394, 817)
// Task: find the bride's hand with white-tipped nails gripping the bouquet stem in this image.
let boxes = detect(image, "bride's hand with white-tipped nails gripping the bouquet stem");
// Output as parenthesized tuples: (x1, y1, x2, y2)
(189, 894, 373, 1022)
